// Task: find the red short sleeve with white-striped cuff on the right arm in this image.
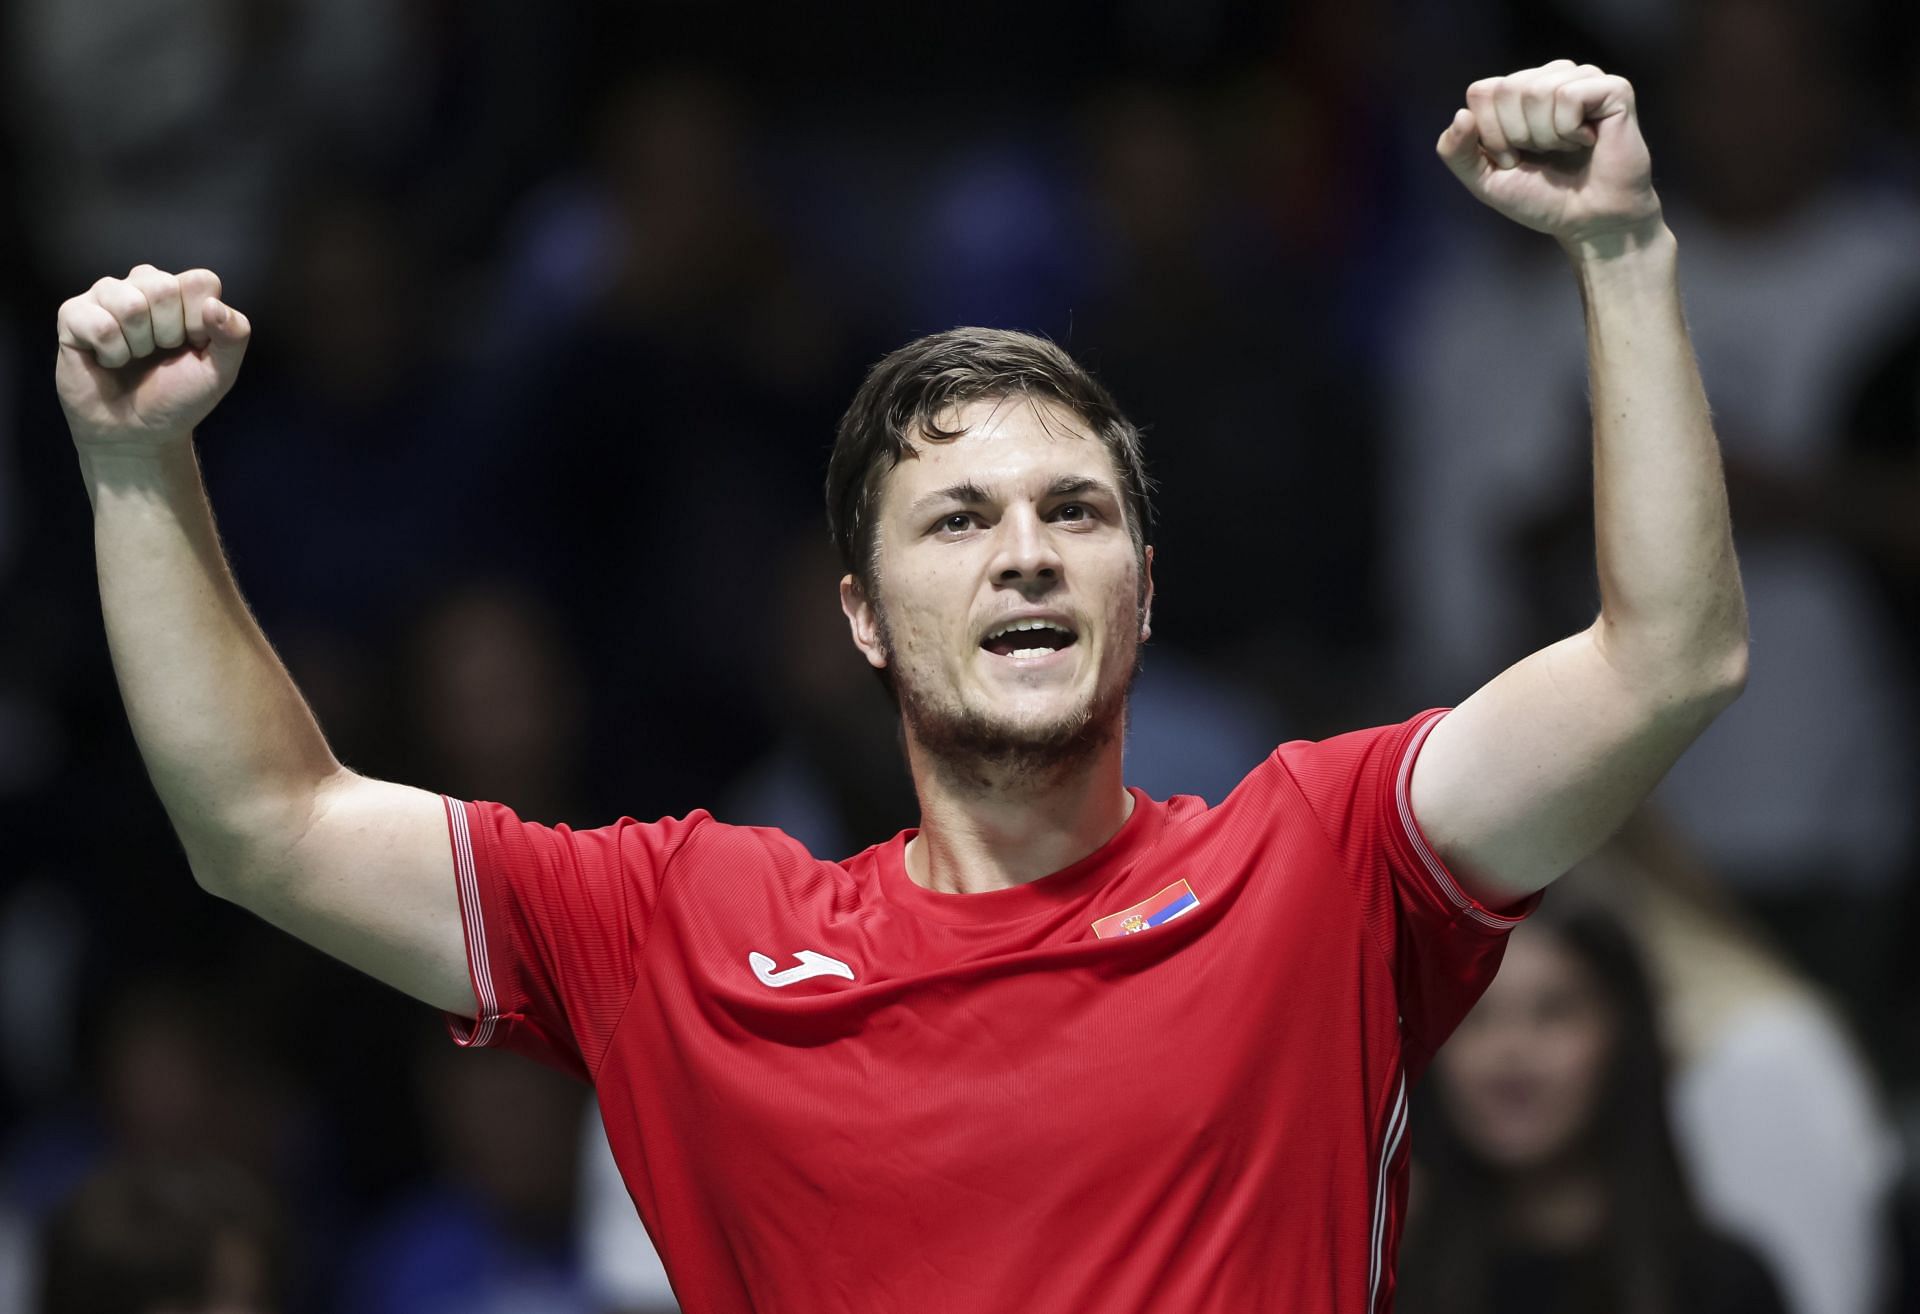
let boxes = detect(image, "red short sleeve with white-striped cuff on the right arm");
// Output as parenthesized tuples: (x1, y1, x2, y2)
(1275, 709, 1540, 1070)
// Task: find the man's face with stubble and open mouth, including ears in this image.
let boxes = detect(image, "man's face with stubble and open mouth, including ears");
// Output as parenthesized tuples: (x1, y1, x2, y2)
(841, 396, 1152, 767)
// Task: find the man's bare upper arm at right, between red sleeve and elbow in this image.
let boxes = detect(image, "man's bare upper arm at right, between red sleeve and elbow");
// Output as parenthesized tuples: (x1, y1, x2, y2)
(1409, 628, 1732, 899)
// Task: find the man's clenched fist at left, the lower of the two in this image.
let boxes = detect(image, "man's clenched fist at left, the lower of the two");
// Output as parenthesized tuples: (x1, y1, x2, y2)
(54, 265, 253, 448)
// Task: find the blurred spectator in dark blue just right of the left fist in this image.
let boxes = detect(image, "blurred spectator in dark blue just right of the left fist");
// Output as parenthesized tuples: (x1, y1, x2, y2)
(202, 179, 515, 649)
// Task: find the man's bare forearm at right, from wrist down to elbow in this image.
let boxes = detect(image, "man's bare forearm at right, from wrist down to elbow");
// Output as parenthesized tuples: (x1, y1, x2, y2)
(1571, 225, 1747, 697)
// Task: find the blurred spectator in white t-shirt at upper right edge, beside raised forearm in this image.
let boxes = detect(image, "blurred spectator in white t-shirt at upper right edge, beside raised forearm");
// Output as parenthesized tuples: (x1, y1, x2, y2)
(1635, 0, 1920, 906)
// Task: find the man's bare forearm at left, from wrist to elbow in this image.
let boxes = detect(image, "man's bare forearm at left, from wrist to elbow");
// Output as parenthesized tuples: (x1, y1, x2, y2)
(81, 440, 340, 886)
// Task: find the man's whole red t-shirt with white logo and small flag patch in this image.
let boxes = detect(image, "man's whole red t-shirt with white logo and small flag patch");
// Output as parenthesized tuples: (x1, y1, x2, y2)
(447, 713, 1538, 1314)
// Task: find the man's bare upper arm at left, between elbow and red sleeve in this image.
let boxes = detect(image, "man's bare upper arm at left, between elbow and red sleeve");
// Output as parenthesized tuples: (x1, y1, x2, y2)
(228, 770, 474, 1016)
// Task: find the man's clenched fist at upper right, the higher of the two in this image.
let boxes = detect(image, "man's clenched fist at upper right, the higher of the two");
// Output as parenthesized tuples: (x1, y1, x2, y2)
(1434, 60, 1661, 248)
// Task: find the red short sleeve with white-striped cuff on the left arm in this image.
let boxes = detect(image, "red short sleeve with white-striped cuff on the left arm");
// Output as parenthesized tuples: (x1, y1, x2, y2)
(442, 795, 708, 1082)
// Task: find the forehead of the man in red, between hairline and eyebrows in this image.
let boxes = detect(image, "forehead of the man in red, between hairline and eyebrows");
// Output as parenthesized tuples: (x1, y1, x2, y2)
(881, 394, 1121, 509)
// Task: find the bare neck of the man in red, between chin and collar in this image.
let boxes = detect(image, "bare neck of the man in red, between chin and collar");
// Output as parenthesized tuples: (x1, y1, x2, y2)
(906, 734, 1133, 893)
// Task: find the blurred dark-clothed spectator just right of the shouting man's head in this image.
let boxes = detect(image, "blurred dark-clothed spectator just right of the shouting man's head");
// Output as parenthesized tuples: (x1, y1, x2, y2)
(1071, 85, 1390, 736)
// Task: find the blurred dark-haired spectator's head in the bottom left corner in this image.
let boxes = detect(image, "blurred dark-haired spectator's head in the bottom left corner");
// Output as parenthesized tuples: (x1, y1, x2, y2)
(36, 1158, 280, 1314)
